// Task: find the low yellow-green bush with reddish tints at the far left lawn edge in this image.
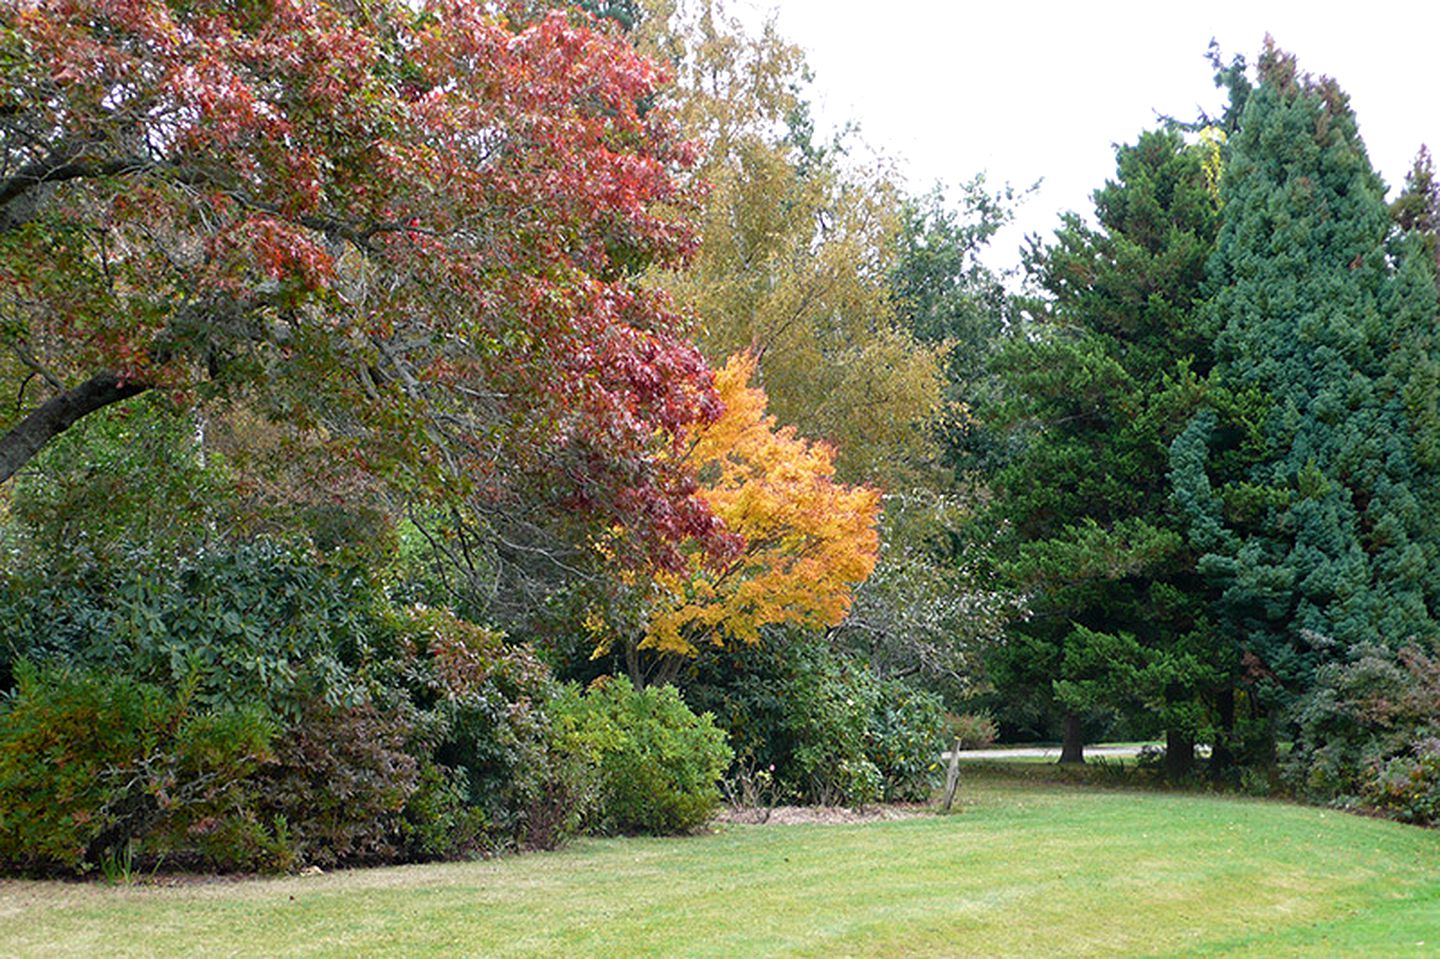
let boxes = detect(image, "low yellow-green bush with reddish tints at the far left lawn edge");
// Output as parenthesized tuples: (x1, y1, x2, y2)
(0, 662, 275, 871)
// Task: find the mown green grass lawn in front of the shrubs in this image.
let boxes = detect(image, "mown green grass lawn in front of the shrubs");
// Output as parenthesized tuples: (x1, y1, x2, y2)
(0, 766, 1440, 958)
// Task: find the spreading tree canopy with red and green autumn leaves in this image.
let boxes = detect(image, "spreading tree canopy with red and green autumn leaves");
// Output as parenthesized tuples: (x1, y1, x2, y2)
(0, 0, 720, 564)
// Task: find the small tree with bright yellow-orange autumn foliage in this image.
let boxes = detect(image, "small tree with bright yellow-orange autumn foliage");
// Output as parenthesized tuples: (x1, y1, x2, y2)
(596, 353, 880, 684)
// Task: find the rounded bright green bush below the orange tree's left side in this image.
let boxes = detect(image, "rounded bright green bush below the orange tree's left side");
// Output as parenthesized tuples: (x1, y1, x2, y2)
(557, 677, 733, 834)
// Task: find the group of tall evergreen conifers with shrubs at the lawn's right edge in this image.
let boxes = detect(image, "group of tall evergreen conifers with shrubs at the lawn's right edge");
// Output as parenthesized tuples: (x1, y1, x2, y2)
(988, 40, 1440, 819)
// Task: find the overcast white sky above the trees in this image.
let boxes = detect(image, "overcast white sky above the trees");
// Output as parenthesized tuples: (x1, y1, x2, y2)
(736, 0, 1440, 265)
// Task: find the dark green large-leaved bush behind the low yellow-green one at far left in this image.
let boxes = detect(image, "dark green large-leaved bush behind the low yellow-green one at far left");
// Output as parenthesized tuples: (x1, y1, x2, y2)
(0, 540, 377, 708)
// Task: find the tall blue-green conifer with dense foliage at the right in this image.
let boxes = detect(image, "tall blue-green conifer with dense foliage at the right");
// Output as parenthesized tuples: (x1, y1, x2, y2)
(1172, 40, 1440, 760)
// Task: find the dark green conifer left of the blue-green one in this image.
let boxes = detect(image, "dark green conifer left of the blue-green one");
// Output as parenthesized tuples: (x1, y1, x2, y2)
(991, 132, 1224, 773)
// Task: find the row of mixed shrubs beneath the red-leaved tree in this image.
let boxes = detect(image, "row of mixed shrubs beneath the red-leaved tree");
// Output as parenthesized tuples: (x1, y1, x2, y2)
(0, 544, 730, 874)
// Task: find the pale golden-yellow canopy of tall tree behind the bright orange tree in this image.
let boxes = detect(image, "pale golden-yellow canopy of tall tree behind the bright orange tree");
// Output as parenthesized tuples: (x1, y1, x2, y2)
(642, 1, 943, 490)
